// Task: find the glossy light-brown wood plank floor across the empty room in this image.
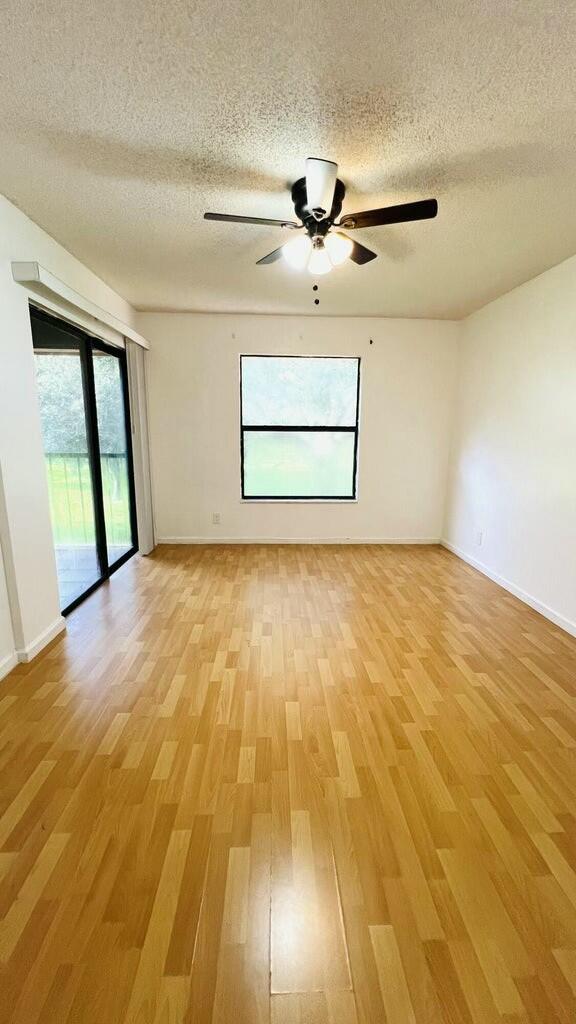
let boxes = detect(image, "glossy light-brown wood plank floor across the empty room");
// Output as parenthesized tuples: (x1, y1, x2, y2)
(0, 546, 576, 1024)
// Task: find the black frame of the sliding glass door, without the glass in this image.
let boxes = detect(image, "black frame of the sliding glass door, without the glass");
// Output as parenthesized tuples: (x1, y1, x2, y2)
(30, 303, 138, 615)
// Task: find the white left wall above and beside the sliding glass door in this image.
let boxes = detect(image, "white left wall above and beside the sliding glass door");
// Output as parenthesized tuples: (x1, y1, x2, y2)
(0, 197, 138, 662)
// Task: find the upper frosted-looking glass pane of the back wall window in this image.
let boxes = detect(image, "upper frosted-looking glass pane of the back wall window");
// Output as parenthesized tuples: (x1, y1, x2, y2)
(242, 355, 359, 427)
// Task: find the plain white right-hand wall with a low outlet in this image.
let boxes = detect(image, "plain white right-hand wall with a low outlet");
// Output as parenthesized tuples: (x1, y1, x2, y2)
(445, 257, 576, 634)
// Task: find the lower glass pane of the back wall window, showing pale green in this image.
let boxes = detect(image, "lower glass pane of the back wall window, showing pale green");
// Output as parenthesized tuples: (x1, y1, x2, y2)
(244, 430, 355, 498)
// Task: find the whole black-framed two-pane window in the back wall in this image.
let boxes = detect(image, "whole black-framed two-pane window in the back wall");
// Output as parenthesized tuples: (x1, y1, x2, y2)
(240, 355, 360, 501)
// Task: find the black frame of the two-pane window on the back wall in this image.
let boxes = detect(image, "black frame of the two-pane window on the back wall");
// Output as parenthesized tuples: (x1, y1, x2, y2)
(240, 352, 362, 502)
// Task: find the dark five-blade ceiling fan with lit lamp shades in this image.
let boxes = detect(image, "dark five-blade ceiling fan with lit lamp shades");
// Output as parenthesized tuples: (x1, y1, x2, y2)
(204, 157, 438, 275)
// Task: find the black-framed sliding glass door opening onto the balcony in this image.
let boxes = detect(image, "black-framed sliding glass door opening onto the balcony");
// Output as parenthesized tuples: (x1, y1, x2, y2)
(31, 309, 136, 612)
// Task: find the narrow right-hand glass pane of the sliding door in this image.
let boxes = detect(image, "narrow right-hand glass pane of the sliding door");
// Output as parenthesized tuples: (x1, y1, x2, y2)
(93, 348, 132, 565)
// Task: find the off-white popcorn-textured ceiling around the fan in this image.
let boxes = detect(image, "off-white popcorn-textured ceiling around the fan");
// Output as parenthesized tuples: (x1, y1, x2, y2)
(0, 0, 576, 317)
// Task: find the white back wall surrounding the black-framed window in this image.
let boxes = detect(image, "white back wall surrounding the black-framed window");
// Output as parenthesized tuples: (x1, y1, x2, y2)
(137, 313, 459, 542)
